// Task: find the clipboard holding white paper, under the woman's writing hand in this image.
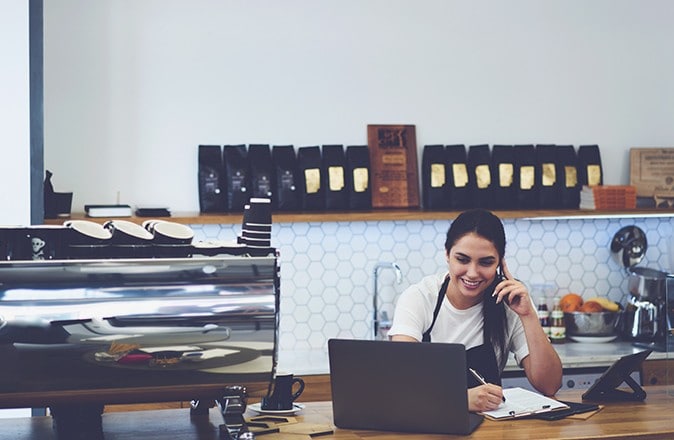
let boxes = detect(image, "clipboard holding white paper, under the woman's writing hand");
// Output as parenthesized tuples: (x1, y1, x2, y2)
(480, 387, 570, 420)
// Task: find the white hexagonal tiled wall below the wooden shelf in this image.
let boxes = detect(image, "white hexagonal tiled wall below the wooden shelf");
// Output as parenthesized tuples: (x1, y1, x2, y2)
(192, 216, 674, 352)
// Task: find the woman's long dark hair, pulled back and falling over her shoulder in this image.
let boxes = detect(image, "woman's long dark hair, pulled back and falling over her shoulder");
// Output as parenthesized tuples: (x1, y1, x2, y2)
(445, 209, 507, 367)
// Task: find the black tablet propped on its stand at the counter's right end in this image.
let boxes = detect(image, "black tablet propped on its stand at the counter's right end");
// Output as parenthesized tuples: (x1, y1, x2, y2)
(583, 350, 653, 400)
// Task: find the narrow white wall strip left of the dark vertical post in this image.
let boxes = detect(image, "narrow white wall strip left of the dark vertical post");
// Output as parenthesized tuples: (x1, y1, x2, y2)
(0, 0, 30, 224)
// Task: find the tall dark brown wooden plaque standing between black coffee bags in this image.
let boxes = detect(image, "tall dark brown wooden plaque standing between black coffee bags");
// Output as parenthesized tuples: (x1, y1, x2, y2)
(367, 125, 419, 208)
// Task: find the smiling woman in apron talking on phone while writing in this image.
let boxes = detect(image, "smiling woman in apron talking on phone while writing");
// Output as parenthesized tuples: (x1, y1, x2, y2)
(388, 209, 562, 411)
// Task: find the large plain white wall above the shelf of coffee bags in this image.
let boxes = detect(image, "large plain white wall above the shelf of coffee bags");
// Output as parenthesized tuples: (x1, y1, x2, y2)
(44, 0, 674, 211)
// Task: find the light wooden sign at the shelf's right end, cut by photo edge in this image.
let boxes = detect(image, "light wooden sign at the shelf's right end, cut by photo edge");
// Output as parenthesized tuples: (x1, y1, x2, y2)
(630, 148, 674, 197)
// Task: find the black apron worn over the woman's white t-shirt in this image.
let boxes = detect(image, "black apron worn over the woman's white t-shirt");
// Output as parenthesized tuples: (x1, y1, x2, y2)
(421, 277, 501, 388)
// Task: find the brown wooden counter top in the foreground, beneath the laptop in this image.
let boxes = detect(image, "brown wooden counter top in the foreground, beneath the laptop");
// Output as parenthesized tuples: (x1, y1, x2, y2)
(0, 386, 674, 440)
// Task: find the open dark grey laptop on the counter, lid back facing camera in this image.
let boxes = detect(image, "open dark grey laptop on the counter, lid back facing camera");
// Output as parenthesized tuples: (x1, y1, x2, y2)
(328, 339, 483, 434)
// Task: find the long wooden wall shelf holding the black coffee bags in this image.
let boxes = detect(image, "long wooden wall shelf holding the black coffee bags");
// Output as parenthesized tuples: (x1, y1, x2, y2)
(45, 209, 674, 225)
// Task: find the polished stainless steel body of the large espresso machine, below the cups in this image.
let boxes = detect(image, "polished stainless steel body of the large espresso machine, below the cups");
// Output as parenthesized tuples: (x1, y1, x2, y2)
(0, 255, 280, 438)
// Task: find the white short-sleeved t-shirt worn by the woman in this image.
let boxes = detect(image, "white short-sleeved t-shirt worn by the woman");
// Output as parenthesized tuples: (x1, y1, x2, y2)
(388, 274, 529, 371)
